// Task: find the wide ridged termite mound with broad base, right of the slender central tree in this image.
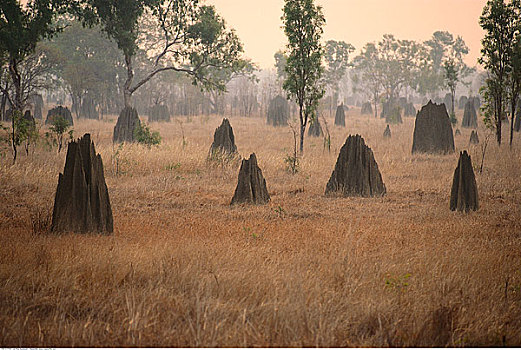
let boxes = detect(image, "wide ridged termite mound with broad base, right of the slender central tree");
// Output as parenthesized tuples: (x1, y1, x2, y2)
(325, 135, 386, 197)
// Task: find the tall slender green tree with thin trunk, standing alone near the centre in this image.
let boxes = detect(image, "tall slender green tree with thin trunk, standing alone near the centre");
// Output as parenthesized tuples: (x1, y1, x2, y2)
(282, 0, 326, 154)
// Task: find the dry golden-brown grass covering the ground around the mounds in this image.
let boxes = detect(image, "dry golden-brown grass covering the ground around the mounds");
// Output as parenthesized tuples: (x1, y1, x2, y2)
(0, 109, 521, 347)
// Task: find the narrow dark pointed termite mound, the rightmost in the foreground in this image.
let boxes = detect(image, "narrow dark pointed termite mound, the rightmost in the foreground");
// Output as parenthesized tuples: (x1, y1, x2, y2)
(450, 151, 479, 212)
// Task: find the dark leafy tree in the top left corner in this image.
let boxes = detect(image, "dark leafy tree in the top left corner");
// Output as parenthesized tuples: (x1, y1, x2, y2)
(0, 0, 72, 163)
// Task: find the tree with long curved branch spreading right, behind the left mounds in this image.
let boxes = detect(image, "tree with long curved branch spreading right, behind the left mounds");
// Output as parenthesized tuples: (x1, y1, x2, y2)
(82, 0, 243, 107)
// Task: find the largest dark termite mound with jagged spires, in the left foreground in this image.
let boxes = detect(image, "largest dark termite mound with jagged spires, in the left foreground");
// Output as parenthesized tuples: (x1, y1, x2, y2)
(51, 134, 113, 234)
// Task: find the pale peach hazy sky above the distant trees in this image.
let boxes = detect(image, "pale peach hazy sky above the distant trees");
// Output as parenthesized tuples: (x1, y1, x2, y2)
(206, 0, 486, 68)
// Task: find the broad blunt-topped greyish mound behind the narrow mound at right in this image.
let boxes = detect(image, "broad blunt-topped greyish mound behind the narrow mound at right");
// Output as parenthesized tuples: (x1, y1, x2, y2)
(412, 101, 454, 153)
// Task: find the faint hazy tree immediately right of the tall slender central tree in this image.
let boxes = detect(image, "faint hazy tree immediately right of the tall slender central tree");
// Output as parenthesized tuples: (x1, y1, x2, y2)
(324, 40, 355, 107)
